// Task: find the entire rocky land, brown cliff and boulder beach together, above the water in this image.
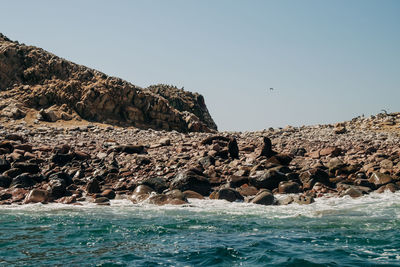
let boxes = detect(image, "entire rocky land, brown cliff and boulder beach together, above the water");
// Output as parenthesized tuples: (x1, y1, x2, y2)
(0, 33, 400, 208)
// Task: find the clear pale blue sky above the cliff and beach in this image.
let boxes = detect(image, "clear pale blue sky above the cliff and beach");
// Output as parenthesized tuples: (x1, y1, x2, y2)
(0, 0, 400, 130)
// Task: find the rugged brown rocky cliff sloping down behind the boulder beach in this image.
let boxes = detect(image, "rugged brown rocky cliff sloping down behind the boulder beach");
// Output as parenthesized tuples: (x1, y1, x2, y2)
(0, 34, 217, 132)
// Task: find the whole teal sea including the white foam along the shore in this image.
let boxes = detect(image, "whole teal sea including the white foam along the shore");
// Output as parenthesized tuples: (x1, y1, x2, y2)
(0, 193, 400, 266)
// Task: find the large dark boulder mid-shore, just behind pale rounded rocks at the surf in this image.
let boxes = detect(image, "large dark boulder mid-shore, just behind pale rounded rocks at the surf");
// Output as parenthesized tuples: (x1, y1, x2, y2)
(170, 171, 211, 196)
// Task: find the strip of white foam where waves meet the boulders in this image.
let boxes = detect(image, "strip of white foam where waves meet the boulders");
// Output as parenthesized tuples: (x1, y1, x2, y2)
(0, 192, 400, 219)
